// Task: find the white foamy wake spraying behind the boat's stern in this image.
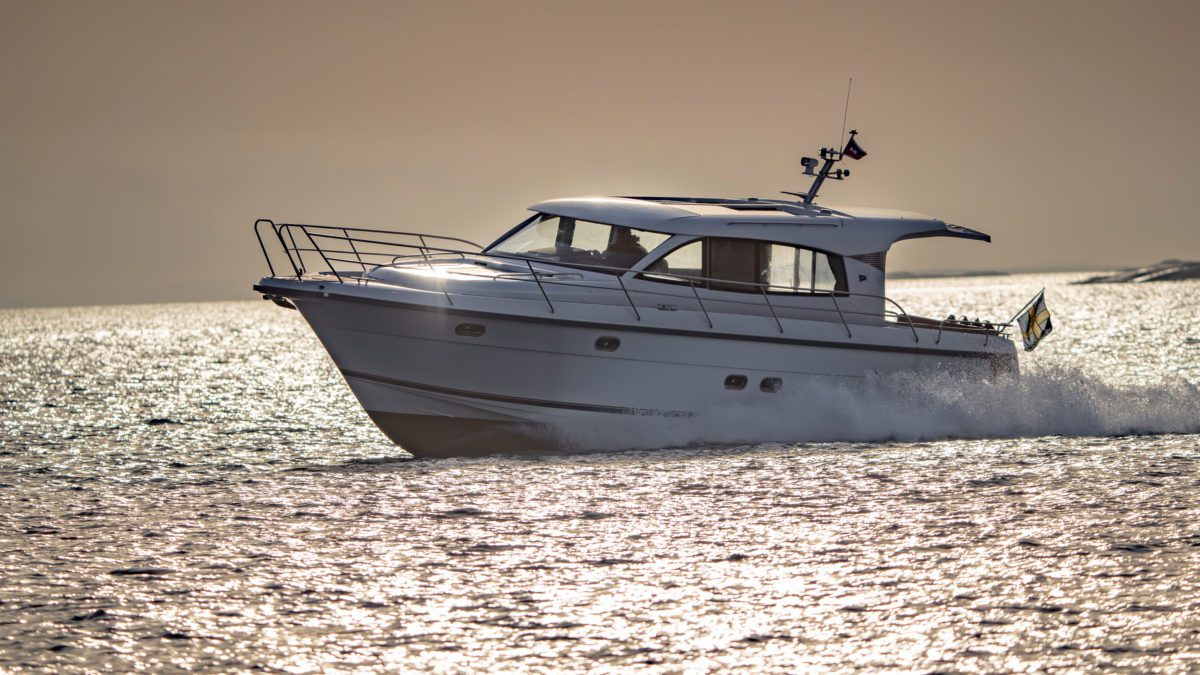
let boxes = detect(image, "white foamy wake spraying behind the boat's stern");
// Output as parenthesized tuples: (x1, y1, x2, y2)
(556, 366, 1200, 449)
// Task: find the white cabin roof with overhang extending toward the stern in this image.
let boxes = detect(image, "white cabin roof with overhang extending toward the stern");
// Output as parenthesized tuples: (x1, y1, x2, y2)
(529, 197, 991, 256)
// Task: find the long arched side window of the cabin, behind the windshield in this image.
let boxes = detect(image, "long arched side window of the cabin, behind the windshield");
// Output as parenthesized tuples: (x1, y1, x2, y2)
(641, 237, 850, 293)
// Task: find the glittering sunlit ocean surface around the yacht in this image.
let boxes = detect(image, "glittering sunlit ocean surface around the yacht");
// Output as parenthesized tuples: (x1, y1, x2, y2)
(0, 270, 1200, 673)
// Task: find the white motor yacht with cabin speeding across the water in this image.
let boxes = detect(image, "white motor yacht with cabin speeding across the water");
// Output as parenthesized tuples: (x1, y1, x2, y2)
(254, 132, 1032, 458)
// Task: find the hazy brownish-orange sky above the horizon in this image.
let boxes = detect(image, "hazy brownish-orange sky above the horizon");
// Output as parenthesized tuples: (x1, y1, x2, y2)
(0, 0, 1200, 306)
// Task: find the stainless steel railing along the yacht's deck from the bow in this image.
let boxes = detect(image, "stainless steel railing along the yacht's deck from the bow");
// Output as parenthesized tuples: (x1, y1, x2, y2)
(254, 219, 1012, 345)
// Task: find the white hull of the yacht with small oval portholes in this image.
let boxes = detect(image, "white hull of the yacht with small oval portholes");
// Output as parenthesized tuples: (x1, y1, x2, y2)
(260, 279, 1015, 456)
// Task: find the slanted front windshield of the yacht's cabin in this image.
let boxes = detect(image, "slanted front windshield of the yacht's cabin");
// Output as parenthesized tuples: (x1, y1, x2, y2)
(487, 215, 671, 271)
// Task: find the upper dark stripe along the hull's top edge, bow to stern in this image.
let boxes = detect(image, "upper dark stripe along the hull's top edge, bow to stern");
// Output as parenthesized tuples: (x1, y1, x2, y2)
(254, 283, 1009, 359)
